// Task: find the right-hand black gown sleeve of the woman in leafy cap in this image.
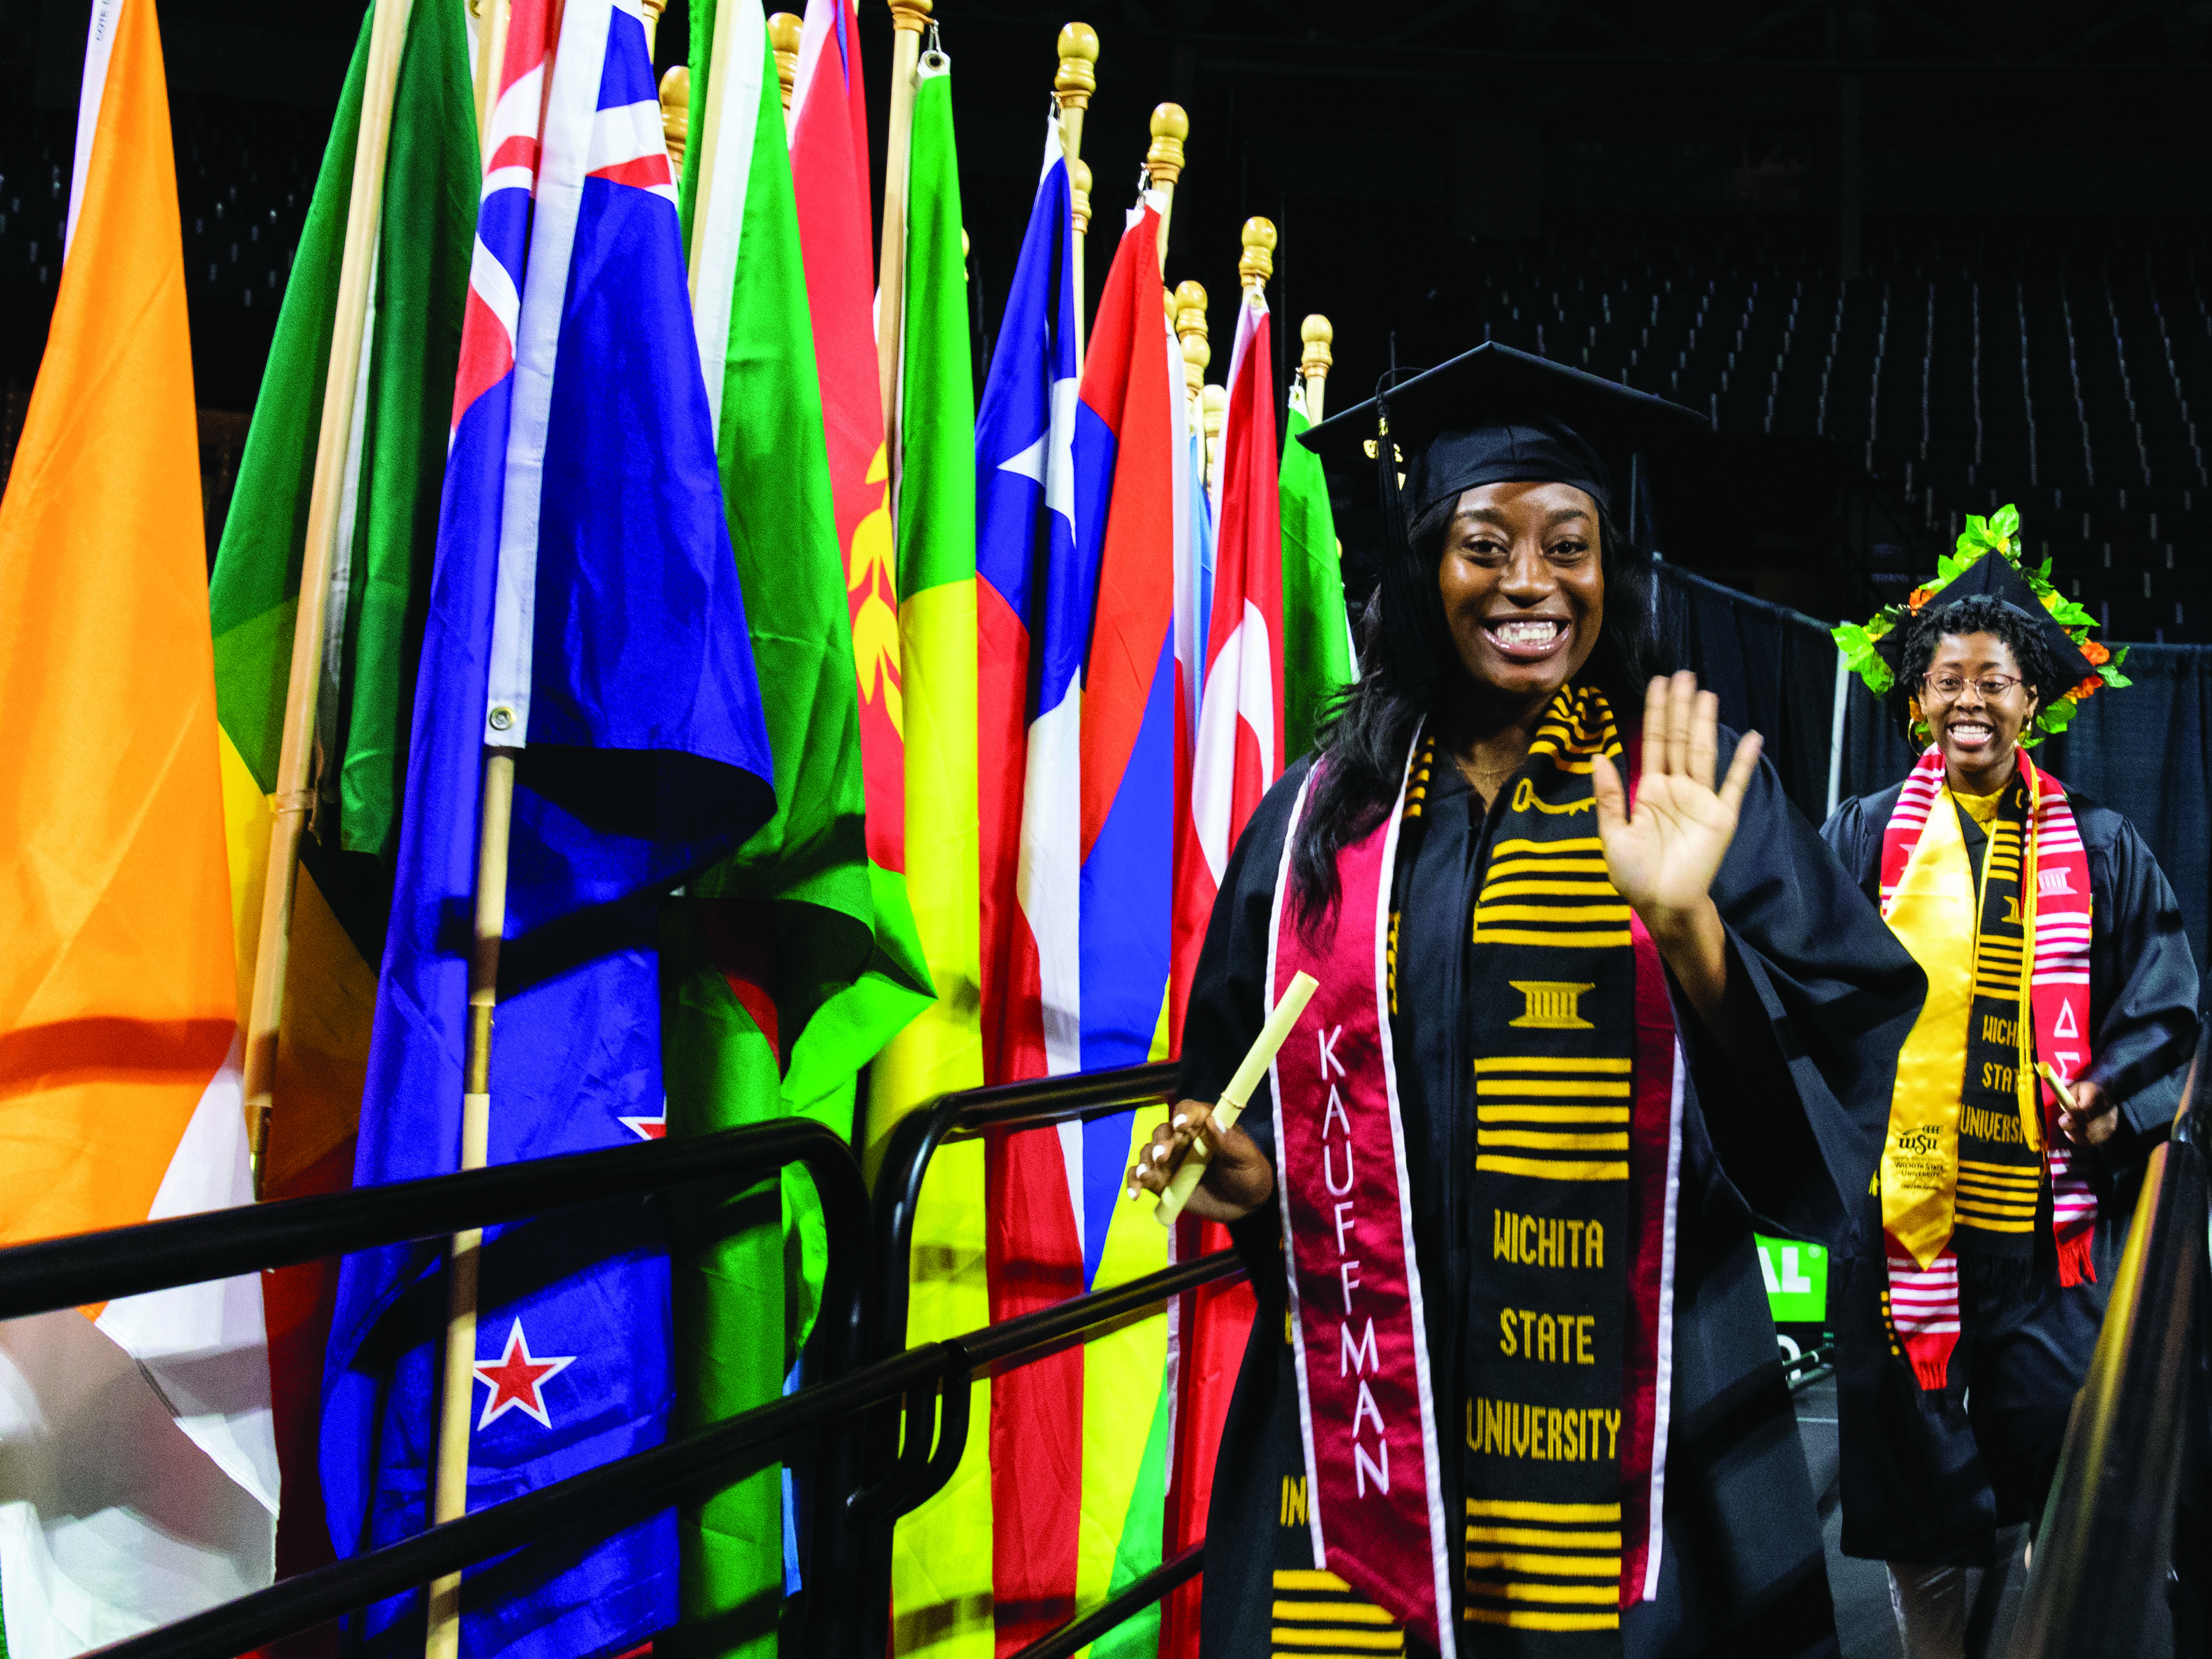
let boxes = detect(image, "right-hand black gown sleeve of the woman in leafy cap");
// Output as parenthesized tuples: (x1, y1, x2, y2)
(2083, 814, 2196, 1166)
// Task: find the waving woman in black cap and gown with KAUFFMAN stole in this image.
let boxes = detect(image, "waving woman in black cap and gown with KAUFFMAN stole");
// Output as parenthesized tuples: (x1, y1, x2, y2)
(1130, 345, 1920, 1659)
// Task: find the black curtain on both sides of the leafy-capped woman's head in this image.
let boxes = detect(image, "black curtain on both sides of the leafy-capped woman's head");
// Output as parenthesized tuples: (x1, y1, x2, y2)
(1659, 564, 2212, 973)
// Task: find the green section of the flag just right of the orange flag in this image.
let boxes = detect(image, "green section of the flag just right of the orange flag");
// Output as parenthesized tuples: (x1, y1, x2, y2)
(208, 5, 482, 876)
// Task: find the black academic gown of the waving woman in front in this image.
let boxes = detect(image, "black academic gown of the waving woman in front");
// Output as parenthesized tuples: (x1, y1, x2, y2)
(1183, 732, 1925, 1659)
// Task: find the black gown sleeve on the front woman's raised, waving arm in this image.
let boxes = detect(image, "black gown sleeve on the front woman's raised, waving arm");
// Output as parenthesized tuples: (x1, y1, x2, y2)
(1681, 735, 1926, 1250)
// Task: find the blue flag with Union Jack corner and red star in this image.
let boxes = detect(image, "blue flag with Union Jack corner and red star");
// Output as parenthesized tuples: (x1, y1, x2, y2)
(323, 0, 774, 1659)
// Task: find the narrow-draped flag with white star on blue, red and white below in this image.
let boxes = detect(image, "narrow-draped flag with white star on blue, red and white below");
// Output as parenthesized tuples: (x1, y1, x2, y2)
(975, 115, 1097, 1650)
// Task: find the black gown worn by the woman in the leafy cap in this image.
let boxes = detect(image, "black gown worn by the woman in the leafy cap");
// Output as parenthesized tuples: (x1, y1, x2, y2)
(1821, 783, 2196, 1566)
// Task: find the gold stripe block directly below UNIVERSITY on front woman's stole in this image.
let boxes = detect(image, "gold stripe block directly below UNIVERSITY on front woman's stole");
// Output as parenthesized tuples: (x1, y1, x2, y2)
(1464, 1497, 1621, 1630)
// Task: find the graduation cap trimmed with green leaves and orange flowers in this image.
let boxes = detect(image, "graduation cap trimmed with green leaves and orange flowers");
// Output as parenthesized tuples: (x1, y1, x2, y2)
(1834, 506, 2128, 747)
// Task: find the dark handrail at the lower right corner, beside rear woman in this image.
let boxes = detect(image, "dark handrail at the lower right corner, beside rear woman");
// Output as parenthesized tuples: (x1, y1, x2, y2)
(2006, 1028, 2212, 1659)
